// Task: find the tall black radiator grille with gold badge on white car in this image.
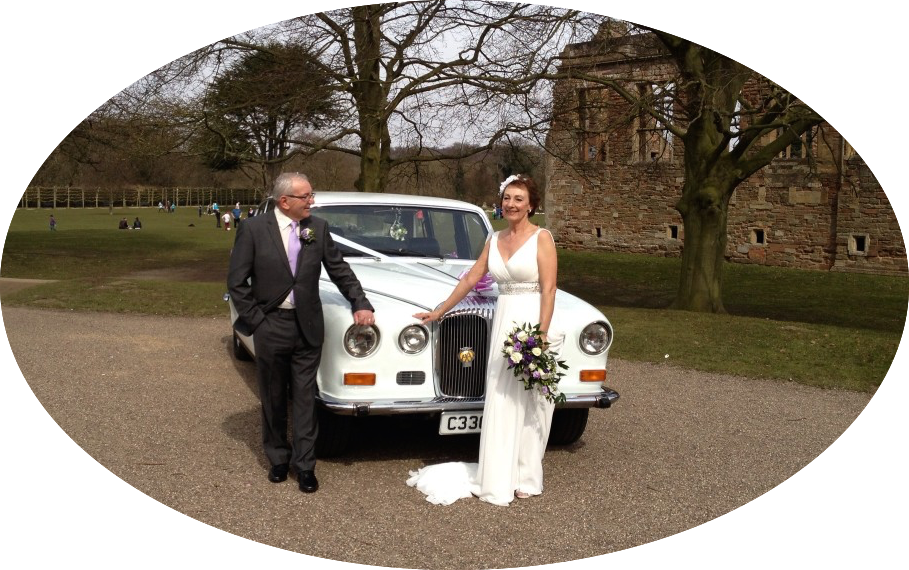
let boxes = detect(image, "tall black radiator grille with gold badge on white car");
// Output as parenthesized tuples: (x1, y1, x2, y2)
(436, 297, 495, 398)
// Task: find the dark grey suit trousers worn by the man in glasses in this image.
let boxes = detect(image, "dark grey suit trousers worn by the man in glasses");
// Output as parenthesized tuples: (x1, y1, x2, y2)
(253, 309, 322, 473)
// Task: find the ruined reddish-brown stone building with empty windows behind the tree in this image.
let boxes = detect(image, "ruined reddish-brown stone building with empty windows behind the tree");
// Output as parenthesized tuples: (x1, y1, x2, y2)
(545, 24, 909, 275)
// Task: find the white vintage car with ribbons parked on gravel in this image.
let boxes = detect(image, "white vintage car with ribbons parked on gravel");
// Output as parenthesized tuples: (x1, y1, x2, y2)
(230, 192, 619, 457)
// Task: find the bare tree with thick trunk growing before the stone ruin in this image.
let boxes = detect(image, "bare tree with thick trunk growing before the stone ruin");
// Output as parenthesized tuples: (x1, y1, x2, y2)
(550, 22, 824, 312)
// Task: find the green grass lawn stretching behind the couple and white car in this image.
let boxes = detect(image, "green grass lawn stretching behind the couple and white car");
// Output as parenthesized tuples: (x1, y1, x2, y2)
(2, 208, 909, 392)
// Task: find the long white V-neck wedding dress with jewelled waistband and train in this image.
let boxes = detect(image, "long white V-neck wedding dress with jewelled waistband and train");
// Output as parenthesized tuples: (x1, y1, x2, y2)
(407, 230, 564, 506)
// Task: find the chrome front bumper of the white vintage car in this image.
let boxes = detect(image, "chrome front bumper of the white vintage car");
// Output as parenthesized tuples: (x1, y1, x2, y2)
(316, 387, 619, 416)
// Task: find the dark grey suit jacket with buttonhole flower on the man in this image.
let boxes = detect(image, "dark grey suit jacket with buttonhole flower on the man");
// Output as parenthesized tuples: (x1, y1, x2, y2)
(227, 210, 374, 346)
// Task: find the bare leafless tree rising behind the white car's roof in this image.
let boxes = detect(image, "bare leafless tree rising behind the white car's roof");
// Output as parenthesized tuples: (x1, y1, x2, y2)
(120, 0, 588, 192)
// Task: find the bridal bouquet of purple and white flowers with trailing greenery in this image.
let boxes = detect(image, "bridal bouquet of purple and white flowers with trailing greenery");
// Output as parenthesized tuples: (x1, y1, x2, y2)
(502, 323, 568, 404)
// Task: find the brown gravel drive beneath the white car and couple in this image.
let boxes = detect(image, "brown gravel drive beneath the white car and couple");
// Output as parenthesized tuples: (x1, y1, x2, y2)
(2, 307, 871, 569)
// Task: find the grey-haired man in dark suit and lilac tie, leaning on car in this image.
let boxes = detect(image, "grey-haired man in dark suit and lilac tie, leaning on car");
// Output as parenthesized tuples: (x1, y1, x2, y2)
(227, 173, 375, 493)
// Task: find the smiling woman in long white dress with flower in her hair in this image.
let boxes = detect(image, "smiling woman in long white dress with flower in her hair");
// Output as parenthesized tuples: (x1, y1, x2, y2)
(407, 174, 564, 506)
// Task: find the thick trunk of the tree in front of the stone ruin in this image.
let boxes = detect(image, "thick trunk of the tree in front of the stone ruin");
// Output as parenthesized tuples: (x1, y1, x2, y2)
(672, 179, 731, 313)
